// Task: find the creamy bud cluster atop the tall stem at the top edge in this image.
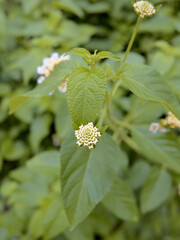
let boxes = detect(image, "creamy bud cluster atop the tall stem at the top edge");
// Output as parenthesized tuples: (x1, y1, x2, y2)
(133, 1, 156, 18)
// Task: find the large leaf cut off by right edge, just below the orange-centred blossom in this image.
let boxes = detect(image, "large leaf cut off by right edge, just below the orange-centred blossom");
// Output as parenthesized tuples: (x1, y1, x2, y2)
(132, 127, 180, 173)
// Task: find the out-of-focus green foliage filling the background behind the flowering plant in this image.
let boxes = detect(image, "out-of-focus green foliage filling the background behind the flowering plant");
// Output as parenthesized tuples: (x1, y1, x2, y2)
(0, 0, 180, 240)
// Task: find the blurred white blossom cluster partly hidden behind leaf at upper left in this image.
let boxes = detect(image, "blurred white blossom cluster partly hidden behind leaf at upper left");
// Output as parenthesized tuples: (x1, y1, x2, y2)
(37, 52, 70, 95)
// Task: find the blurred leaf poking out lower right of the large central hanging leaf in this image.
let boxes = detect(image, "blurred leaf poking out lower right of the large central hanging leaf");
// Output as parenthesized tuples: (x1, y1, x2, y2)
(103, 179, 139, 221)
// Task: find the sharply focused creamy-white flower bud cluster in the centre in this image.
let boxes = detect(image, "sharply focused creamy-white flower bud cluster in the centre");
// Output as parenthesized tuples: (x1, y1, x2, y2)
(75, 122, 101, 149)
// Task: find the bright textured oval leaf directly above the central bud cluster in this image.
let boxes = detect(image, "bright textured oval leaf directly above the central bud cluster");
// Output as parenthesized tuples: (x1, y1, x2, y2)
(67, 67, 106, 125)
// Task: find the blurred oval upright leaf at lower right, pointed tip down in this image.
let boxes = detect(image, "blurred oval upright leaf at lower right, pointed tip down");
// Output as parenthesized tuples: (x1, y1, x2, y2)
(140, 168, 172, 213)
